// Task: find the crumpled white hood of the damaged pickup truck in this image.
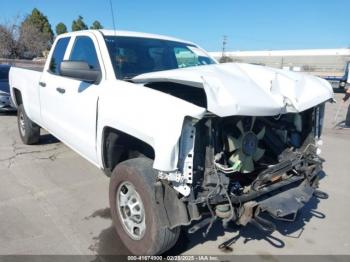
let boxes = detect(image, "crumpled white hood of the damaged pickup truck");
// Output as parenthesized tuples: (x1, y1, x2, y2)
(132, 63, 334, 117)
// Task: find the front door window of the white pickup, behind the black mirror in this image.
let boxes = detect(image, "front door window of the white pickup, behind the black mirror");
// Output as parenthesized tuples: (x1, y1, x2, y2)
(69, 36, 100, 70)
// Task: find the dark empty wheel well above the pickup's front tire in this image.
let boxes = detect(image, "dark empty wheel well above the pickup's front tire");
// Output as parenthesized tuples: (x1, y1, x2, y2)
(102, 127, 155, 176)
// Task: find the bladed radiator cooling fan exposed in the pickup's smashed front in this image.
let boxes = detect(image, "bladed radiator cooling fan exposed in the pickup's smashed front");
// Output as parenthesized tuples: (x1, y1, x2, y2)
(227, 117, 265, 173)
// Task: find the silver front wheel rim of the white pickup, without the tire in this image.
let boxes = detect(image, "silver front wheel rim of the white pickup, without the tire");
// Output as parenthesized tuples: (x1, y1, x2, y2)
(116, 182, 146, 240)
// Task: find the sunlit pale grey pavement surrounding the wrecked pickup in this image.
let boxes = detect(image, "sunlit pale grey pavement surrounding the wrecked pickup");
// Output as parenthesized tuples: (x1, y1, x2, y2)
(0, 92, 350, 255)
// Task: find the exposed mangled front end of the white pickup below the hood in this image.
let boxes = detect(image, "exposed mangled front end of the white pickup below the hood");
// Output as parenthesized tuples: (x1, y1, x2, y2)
(159, 104, 324, 233)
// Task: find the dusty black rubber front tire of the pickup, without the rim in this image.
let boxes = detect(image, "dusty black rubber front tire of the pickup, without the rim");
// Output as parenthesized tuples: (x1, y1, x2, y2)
(109, 158, 180, 255)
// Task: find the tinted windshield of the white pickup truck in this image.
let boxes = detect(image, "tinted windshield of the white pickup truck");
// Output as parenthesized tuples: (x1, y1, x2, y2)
(105, 36, 216, 79)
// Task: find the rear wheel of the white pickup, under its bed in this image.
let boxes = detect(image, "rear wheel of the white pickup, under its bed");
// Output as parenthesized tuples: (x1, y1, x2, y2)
(17, 104, 40, 145)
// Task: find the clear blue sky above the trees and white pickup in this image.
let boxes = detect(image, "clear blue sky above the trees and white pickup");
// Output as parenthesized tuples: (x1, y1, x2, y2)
(0, 0, 350, 51)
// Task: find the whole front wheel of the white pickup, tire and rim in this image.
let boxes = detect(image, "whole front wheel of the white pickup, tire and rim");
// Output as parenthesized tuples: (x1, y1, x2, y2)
(109, 158, 180, 255)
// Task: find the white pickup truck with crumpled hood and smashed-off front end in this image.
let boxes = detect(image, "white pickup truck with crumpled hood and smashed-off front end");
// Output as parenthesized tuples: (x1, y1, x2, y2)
(10, 30, 333, 254)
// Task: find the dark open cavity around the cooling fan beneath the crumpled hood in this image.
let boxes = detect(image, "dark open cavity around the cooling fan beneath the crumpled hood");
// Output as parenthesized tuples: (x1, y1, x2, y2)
(200, 108, 312, 186)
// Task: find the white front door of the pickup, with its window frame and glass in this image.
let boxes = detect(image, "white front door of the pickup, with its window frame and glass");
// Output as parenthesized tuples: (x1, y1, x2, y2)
(40, 33, 102, 163)
